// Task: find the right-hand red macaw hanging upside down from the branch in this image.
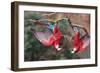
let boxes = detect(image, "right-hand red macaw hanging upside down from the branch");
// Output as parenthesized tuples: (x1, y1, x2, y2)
(72, 28, 89, 53)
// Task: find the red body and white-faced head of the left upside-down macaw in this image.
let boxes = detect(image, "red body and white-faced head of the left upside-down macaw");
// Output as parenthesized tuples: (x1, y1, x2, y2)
(42, 25, 62, 50)
